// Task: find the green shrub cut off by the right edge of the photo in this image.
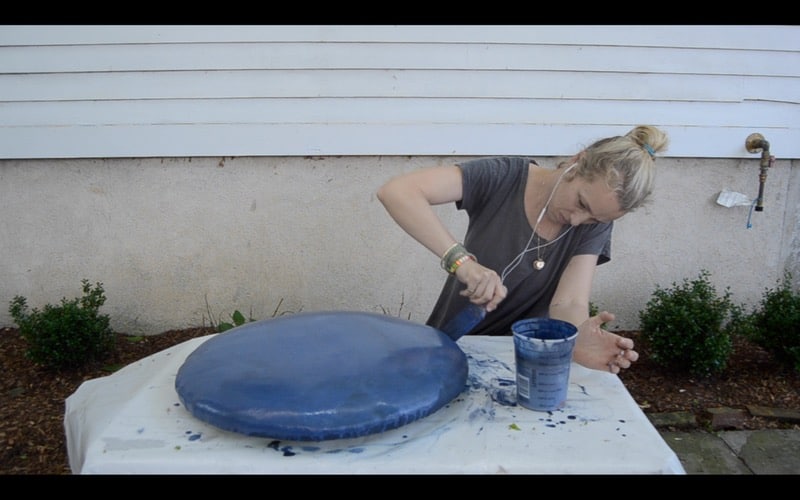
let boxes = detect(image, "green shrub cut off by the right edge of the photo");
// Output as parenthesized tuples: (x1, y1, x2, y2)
(738, 271, 800, 372)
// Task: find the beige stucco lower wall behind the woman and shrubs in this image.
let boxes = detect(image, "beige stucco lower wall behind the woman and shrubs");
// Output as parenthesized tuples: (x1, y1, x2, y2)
(0, 157, 800, 334)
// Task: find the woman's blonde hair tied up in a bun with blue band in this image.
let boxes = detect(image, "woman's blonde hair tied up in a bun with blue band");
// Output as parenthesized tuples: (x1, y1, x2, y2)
(573, 125, 669, 212)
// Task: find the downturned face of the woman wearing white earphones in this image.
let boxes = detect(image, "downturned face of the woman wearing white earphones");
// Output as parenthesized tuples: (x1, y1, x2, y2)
(547, 176, 625, 226)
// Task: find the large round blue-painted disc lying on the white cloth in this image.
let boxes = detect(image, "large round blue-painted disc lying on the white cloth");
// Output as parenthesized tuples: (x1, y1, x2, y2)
(175, 311, 467, 441)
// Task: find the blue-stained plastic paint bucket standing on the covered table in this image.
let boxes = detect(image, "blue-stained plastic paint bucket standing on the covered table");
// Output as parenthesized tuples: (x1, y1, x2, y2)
(511, 318, 578, 411)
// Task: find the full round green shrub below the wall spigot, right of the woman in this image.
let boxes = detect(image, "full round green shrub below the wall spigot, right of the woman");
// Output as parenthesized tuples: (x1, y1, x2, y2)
(639, 270, 740, 377)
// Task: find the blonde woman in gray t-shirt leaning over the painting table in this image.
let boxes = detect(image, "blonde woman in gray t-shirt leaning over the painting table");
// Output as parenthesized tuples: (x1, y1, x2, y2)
(377, 125, 668, 373)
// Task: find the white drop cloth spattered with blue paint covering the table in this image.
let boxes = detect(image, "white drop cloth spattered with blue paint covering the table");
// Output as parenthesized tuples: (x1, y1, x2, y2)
(64, 336, 685, 474)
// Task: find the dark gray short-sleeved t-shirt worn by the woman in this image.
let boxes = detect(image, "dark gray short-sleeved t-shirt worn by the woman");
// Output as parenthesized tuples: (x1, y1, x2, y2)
(426, 157, 613, 335)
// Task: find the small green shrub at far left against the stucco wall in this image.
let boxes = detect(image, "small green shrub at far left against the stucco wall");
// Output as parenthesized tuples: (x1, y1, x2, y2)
(9, 280, 116, 369)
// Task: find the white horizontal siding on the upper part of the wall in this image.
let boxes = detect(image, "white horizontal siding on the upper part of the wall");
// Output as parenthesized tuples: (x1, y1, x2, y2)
(0, 26, 800, 158)
